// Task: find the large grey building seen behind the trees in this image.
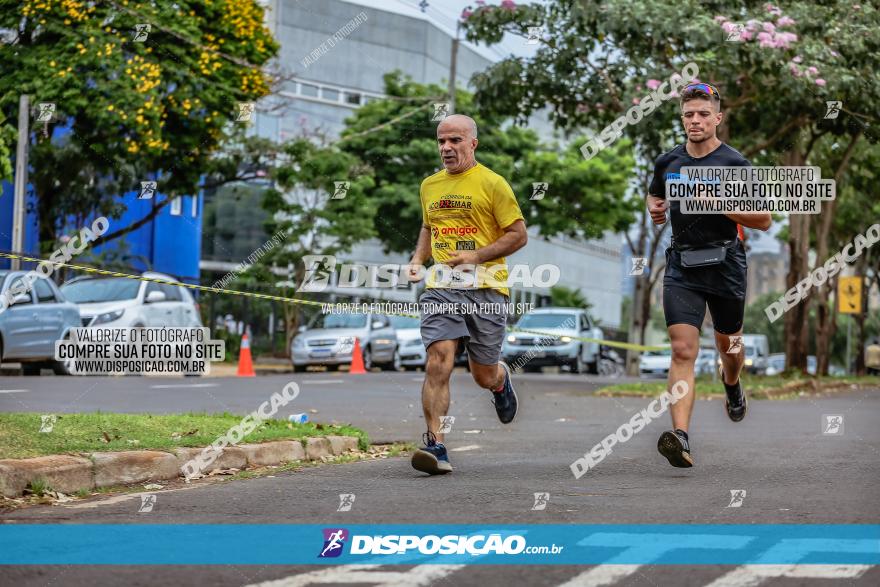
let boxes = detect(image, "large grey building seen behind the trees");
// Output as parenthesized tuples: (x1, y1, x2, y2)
(201, 0, 622, 329)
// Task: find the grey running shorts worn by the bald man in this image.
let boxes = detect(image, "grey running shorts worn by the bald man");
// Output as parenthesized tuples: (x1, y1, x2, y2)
(419, 287, 508, 365)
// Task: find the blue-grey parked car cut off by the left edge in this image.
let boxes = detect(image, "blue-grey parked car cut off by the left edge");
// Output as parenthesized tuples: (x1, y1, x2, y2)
(0, 270, 82, 375)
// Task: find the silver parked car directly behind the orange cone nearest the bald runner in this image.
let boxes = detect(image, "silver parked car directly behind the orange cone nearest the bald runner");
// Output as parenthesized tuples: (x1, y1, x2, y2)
(290, 314, 400, 371)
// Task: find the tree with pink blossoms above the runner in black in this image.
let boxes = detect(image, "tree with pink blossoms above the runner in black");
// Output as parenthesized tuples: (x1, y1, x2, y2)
(462, 0, 880, 369)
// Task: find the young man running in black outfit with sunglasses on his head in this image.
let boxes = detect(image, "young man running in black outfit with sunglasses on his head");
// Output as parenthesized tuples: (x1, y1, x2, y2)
(646, 83, 771, 467)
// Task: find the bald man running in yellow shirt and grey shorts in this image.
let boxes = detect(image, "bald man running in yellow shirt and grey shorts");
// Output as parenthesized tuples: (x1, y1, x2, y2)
(409, 114, 528, 475)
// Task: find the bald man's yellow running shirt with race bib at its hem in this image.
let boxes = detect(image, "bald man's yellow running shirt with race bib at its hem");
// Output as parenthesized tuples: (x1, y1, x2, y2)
(419, 163, 524, 295)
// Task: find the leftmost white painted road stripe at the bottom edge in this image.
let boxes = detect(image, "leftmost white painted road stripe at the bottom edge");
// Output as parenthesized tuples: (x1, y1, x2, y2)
(247, 565, 465, 587)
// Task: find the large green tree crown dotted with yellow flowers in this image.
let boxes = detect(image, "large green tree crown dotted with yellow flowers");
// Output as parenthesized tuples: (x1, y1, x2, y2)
(0, 0, 278, 247)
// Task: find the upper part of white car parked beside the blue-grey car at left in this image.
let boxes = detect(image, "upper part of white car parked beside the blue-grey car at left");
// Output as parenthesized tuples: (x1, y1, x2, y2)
(61, 271, 202, 328)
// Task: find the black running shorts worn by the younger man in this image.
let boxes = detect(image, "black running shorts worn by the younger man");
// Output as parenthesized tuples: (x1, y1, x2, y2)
(663, 283, 746, 334)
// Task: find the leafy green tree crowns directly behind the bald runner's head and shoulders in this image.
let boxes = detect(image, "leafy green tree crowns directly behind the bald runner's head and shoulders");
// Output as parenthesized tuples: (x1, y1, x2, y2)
(340, 73, 635, 252)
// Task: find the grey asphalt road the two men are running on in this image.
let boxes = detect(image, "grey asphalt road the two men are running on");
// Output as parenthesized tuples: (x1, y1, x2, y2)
(0, 373, 880, 587)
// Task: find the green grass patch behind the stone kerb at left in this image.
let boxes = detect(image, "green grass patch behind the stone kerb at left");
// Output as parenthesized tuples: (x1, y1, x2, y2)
(0, 412, 369, 459)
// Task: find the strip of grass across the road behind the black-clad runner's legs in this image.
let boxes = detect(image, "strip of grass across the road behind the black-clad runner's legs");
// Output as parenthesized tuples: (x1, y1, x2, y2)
(596, 373, 880, 399)
